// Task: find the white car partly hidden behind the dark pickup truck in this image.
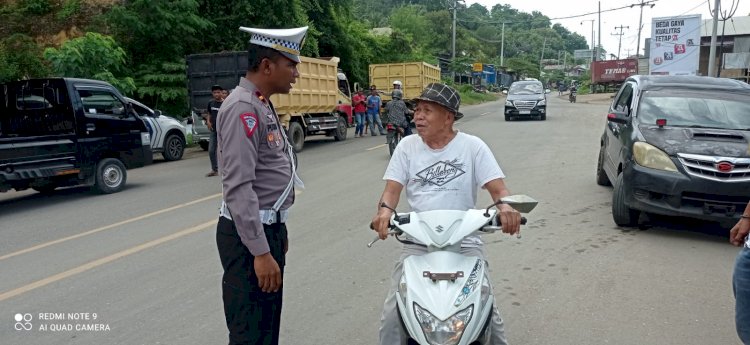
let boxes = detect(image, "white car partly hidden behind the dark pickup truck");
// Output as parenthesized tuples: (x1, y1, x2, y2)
(125, 97, 186, 161)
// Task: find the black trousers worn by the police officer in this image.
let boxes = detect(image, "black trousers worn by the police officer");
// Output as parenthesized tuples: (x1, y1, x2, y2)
(216, 217, 287, 345)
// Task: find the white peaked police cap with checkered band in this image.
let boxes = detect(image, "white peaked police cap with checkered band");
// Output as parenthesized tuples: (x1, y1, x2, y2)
(240, 26, 308, 62)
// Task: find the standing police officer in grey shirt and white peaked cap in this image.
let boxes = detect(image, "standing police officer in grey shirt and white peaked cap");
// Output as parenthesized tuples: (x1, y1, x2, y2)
(216, 27, 307, 345)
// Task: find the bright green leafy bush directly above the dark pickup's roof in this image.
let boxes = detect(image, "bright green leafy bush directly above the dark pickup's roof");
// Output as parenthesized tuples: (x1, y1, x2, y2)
(44, 32, 136, 94)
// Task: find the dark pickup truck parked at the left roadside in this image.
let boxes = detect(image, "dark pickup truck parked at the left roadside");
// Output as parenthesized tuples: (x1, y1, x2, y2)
(0, 78, 153, 193)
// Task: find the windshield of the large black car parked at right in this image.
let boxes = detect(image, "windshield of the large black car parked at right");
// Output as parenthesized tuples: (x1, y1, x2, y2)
(637, 90, 750, 130)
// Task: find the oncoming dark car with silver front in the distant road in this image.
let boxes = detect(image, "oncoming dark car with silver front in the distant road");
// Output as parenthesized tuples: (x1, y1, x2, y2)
(504, 80, 549, 121)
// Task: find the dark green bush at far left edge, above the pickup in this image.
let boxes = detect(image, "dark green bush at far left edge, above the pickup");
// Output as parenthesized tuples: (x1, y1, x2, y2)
(0, 34, 49, 82)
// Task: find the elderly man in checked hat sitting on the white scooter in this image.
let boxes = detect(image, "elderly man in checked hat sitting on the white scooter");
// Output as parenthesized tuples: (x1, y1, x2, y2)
(372, 83, 521, 345)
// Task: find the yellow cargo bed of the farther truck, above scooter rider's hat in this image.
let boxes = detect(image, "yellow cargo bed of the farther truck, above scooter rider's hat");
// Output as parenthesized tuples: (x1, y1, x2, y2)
(370, 61, 440, 103)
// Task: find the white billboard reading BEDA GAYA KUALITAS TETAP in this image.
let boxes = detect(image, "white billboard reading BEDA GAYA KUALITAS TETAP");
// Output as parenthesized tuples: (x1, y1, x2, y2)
(649, 14, 703, 75)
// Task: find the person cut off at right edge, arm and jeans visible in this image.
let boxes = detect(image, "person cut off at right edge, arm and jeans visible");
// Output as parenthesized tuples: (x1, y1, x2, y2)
(729, 202, 750, 345)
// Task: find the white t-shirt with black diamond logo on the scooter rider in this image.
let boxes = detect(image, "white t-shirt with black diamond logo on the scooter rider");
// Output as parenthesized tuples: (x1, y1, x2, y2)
(383, 132, 505, 247)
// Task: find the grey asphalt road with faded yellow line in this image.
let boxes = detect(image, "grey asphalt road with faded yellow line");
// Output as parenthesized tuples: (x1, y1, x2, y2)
(0, 95, 739, 345)
